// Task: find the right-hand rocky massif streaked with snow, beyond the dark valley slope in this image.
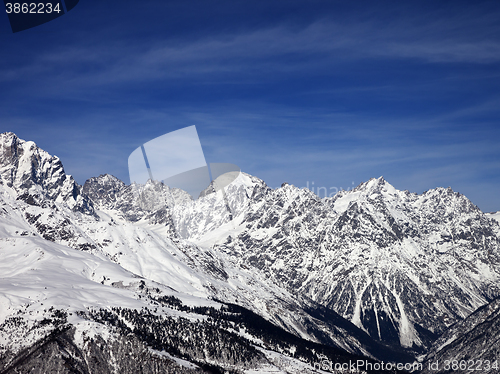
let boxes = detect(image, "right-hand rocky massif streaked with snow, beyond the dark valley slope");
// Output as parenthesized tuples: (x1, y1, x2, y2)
(182, 178, 500, 349)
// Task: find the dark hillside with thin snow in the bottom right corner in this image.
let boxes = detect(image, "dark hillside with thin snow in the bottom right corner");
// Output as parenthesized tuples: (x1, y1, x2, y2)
(422, 299, 500, 373)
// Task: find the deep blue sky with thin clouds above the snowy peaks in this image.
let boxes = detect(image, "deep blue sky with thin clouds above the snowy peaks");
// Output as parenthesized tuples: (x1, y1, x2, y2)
(0, 0, 500, 211)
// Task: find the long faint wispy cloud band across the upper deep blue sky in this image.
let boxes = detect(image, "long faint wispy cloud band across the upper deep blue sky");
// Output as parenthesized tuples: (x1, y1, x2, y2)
(0, 8, 500, 98)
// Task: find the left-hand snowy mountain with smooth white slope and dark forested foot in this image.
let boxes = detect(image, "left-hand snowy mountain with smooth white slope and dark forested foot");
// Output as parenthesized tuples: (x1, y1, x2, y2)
(0, 133, 411, 373)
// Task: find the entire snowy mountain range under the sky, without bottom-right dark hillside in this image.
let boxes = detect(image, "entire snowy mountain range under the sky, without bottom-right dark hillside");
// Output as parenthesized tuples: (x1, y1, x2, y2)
(0, 133, 500, 373)
